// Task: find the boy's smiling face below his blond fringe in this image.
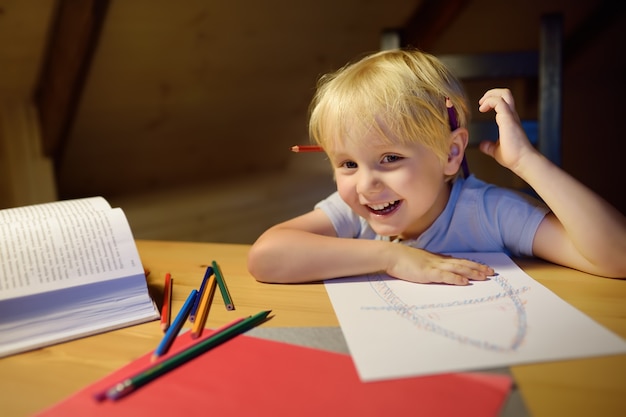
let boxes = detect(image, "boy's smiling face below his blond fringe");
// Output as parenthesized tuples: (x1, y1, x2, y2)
(329, 130, 450, 239)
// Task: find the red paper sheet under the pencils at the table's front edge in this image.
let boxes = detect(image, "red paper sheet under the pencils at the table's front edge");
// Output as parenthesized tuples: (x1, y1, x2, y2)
(38, 332, 511, 417)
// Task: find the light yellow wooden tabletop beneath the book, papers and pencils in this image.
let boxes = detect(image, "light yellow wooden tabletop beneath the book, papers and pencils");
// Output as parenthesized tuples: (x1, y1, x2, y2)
(0, 241, 626, 417)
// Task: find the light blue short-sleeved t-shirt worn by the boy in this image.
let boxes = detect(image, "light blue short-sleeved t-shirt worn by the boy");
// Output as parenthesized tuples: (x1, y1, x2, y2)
(315, 176, 549, 256)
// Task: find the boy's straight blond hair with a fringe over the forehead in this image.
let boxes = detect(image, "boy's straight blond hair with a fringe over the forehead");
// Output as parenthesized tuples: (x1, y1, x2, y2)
(309, 49, 469, 161)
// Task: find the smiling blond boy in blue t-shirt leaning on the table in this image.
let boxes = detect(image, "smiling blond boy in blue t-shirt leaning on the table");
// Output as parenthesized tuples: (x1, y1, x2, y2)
(248, 50, 626, 285)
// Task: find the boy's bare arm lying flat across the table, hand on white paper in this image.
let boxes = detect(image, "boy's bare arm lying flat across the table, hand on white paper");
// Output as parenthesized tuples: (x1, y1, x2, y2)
(248, 210, 493, 285)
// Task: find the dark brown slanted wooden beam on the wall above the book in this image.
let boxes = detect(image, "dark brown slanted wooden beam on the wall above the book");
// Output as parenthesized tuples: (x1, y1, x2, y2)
(35, 0, 109, 162)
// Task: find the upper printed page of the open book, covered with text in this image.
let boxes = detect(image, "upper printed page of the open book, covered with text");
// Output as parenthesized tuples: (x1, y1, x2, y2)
(0, 198, 142, 300)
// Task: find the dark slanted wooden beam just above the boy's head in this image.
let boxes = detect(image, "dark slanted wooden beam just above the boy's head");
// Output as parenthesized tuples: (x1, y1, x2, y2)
(401, 0, 470, 50)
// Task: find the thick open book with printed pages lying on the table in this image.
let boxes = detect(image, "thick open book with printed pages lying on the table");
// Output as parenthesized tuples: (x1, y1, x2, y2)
(0, 197, 159, 357)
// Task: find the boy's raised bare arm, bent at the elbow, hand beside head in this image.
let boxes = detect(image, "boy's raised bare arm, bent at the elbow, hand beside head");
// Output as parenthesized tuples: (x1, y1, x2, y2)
(480, 89, 626, 278)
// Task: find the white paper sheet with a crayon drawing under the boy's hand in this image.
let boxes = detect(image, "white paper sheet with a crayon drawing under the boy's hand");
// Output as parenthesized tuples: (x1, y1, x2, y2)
(325, 253, 626, 381)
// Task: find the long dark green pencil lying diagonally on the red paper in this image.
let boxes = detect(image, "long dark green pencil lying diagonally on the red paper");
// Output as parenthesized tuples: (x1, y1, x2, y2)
(106, 310, 271, 401)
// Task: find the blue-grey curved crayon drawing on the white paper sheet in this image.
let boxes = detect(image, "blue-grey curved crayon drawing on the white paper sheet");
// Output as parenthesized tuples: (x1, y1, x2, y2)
(361, 275, 530, 352)
